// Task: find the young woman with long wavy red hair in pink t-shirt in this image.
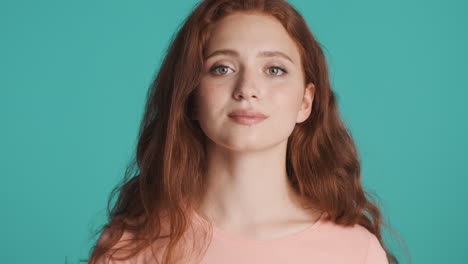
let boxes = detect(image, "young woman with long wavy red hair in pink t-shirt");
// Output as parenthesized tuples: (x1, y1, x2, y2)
(89, 0, 398, 264)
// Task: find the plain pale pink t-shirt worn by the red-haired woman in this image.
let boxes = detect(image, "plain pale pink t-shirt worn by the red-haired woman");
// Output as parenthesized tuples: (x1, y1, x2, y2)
(99, 210, 388, 264)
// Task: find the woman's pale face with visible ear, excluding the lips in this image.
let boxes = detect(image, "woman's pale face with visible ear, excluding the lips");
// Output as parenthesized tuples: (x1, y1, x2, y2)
(195, 13, 315, 151)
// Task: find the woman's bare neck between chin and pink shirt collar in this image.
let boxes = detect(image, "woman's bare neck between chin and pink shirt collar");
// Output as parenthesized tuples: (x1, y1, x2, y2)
(196, 138, 312, 225)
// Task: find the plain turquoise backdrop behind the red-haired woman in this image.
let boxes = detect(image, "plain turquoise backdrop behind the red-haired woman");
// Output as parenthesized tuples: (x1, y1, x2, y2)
(0, 0, 468, 264)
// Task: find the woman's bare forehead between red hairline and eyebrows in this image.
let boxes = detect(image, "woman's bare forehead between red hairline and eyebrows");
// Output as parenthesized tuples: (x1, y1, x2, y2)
(205, 13, 300, 62)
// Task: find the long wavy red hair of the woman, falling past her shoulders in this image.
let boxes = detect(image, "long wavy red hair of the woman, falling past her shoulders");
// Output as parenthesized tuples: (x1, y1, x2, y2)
(89, 0, 410, 264)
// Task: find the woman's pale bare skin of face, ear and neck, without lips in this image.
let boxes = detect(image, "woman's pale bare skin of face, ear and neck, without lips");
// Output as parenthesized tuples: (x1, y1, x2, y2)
(191, 13, 321, 240)
